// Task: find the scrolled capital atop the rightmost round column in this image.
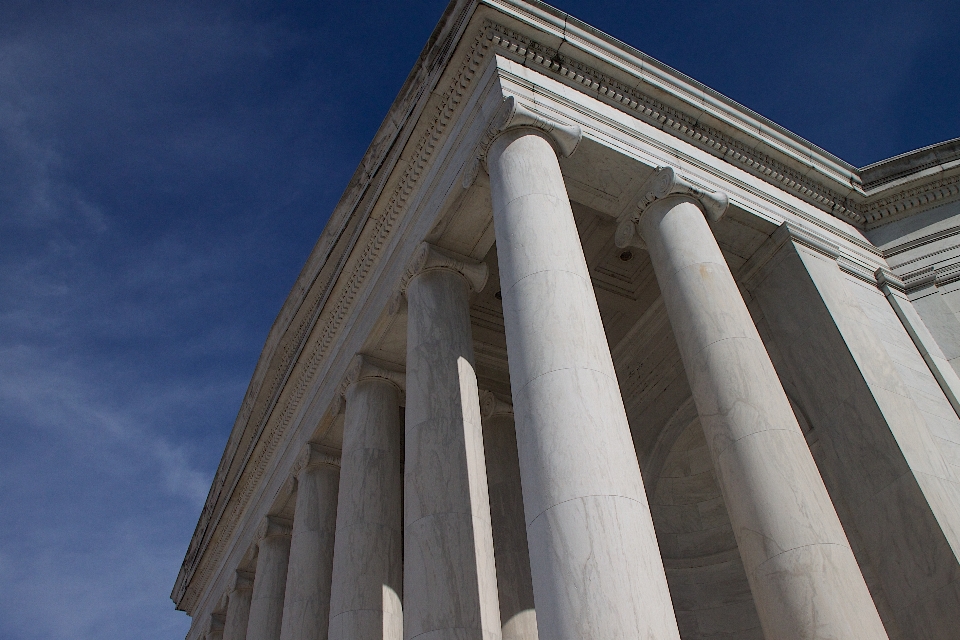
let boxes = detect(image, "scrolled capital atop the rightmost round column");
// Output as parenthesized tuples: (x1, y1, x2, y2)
(614, 167, 730, 249)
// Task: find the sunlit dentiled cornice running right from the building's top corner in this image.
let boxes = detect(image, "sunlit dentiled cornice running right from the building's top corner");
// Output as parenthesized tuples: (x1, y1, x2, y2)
(484, 14, 960, 228)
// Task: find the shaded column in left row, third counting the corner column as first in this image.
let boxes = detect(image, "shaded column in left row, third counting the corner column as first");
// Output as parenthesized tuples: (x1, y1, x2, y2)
(330, 356, 404, 640)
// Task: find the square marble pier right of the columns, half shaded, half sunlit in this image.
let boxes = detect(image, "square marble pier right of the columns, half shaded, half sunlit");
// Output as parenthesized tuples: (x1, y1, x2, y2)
(754, 236, 960, 640)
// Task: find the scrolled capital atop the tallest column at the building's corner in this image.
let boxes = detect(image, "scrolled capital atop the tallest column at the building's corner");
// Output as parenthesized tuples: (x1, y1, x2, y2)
(463, 96, 583, 189)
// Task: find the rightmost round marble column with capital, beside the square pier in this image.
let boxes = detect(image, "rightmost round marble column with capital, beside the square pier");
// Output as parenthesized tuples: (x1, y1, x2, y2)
(617, 168, 887, 640)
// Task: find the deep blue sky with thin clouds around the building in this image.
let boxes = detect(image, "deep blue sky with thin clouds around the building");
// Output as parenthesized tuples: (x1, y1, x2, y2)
(0, 0, 960, 640)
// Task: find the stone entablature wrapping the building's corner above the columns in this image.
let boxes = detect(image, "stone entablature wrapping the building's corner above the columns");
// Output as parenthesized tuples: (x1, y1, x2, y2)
(173, 1, 960, 626)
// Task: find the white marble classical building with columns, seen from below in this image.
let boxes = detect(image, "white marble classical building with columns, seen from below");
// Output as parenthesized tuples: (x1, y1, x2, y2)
(172, 0, 960, 640)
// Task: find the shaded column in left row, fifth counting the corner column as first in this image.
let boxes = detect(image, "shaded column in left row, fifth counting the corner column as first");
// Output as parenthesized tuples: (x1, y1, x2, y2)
(247, 516, 290, 640)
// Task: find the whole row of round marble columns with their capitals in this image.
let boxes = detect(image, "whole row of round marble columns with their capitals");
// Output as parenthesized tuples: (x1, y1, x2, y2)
(212, 100, 886, 640)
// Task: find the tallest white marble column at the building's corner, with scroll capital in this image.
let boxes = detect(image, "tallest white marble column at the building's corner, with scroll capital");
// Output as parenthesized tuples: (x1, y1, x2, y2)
(487, 99, 680, 640)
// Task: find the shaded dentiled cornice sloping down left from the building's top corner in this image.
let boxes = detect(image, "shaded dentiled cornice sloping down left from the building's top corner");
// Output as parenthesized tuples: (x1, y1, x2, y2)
(171, 3, 490, 613)
